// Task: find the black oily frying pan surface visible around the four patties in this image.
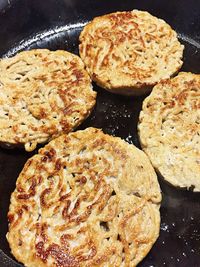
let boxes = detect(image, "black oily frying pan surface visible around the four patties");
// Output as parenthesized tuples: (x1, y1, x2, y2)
(0, 0, 200, 267)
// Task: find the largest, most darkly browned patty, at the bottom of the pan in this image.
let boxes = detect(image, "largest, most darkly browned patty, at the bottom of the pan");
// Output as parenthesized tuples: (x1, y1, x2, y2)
(7, 128, 161, 267)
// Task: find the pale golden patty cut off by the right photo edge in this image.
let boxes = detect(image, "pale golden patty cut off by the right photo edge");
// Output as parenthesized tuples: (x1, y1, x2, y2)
(138, 72, 200, 191)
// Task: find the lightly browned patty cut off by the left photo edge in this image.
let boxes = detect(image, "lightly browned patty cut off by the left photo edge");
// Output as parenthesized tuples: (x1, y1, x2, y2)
(0, 49, 96, 151)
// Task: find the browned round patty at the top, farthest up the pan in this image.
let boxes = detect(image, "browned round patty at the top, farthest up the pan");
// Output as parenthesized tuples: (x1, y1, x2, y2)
(79, 10, 184, 95)
